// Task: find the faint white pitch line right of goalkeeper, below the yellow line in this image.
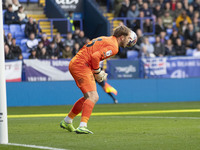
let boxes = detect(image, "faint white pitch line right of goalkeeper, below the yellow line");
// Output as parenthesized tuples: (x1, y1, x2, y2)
(103, 116, 200, 119)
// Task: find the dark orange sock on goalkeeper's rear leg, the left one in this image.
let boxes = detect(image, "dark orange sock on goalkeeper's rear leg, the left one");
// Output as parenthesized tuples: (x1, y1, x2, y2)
(68, 97, 85, 119)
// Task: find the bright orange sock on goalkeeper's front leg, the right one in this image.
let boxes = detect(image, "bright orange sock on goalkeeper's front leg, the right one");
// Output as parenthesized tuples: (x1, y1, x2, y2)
(81, 99, 94, 123)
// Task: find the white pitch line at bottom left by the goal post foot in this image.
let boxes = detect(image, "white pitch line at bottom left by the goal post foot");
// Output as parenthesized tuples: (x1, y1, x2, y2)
(5, 143, 69, 150)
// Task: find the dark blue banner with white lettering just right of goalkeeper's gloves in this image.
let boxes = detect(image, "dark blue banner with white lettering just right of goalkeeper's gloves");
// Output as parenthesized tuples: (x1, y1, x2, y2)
(107, 59, 139, 79)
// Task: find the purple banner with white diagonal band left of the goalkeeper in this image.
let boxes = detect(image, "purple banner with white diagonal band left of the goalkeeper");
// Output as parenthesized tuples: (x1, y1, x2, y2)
(24, 59, 73, 81)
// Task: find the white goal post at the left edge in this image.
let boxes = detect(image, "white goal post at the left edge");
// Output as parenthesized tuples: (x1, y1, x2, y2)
(0, 0, 8, 144)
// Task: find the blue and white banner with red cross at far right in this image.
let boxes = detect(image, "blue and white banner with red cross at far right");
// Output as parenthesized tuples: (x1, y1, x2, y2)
(142, 57, 200, 78)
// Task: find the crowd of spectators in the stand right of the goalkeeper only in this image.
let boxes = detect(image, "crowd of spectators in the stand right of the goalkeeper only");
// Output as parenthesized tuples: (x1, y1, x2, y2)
(99, 0, 200, 58)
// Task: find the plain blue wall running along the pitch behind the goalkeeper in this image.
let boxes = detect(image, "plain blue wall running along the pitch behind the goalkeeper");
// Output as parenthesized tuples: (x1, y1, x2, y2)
(7, 78, 200, 106)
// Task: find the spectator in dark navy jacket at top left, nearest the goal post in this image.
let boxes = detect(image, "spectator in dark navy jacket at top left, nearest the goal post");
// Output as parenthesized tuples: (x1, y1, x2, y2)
(4, 4, 19, 25)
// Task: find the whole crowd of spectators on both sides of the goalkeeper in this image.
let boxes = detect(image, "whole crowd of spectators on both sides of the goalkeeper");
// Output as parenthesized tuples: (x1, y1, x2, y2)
(4, 0, 200, 59)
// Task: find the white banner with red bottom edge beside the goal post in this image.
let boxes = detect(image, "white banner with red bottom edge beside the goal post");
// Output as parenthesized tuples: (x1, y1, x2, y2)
(5, 61, 22, 82)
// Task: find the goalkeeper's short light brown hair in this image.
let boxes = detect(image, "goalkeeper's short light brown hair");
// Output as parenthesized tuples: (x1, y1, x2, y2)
(113, 25, 131, 37)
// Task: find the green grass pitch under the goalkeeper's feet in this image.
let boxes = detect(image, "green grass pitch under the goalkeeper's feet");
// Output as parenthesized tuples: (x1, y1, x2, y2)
(0, 102, 200, 150)
